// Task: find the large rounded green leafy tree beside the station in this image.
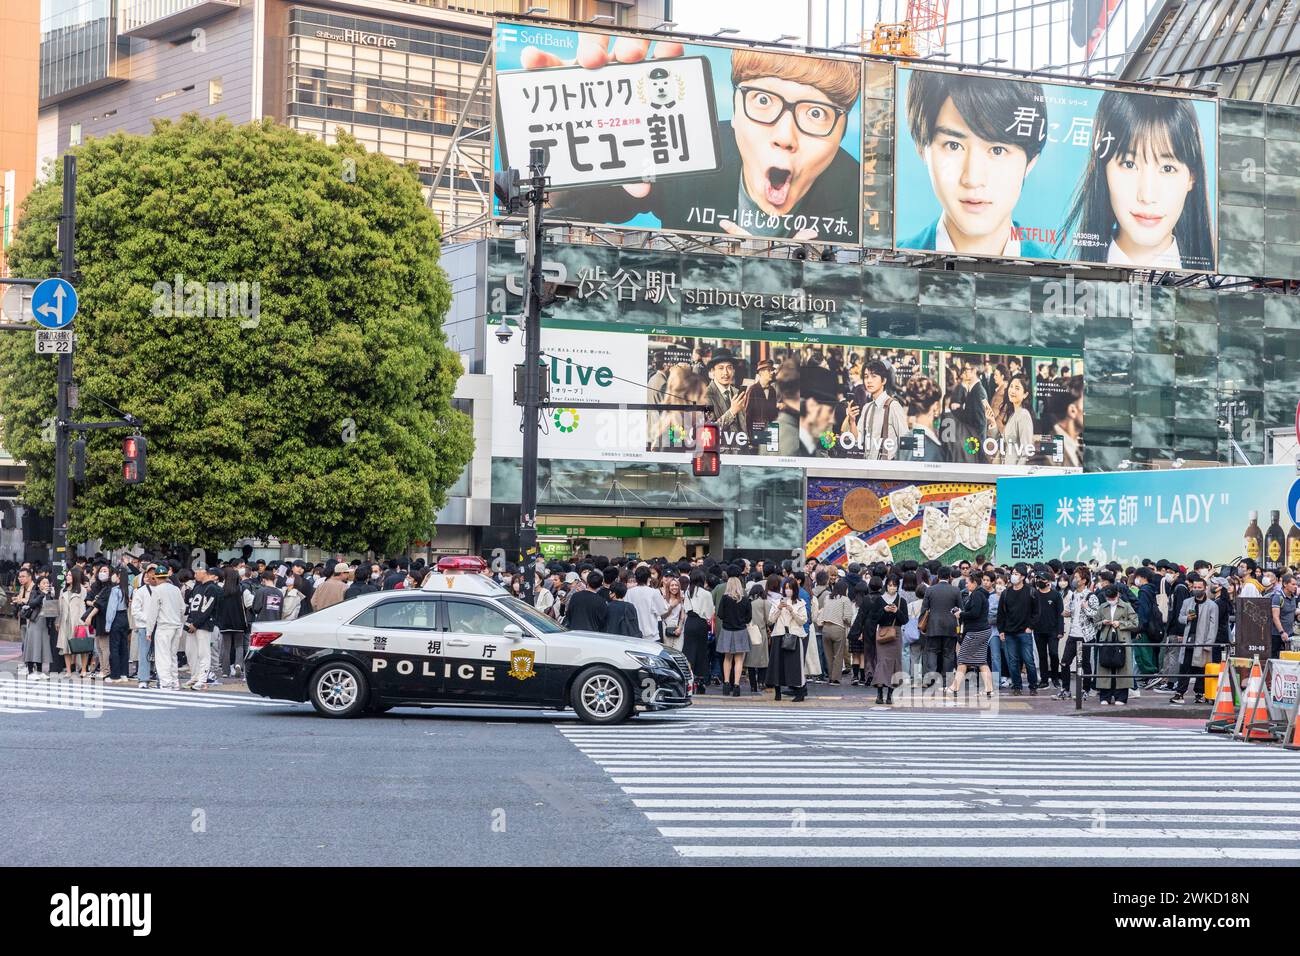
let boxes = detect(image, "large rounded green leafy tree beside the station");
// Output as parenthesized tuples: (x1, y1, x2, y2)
(0, 116, 472, 551)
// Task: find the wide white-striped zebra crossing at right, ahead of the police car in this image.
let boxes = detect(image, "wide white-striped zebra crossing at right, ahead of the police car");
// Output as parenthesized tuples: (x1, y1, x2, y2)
(559, 708, 1300, 865)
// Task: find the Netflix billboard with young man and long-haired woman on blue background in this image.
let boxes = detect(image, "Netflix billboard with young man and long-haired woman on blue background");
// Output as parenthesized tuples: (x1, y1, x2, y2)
(894, 66, 1218, 272)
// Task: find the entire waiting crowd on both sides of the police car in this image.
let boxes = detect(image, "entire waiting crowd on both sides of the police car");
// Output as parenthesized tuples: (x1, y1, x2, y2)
(9, 554, 1300, 705)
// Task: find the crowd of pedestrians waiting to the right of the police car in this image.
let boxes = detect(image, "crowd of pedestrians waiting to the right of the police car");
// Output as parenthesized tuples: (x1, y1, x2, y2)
(514, 555, 1300, 706)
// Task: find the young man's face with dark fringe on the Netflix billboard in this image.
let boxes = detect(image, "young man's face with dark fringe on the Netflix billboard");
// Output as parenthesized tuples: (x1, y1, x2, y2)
(922, 98, 1034, 255)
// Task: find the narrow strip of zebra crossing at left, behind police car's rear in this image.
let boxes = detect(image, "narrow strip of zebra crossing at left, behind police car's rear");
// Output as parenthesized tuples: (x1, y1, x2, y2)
(0, 679, 283, 715)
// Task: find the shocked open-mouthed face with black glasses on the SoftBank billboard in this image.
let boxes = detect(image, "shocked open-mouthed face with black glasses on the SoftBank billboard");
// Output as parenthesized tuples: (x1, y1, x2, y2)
(732, 77, 848, 216)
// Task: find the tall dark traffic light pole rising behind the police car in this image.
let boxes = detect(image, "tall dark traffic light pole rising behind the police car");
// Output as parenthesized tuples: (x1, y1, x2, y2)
(519, 150, 546, 605)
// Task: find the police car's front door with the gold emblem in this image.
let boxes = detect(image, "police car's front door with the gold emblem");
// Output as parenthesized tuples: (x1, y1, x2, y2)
(442, 596, 543, 705)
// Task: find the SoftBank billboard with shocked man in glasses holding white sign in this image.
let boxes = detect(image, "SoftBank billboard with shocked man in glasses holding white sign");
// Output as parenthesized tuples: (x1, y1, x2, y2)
(493, 22, 862, 245)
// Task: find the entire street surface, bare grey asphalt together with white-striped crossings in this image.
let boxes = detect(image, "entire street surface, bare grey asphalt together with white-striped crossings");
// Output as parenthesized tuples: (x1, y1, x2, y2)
(0, 682, 1300, 866)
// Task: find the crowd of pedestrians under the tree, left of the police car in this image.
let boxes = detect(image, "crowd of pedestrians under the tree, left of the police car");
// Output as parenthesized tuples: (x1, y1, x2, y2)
(7, 553, 441, 691)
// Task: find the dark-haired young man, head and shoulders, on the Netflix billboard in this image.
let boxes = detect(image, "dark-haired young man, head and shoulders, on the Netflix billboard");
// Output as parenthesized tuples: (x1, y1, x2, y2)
(898, 70, 1052, 259)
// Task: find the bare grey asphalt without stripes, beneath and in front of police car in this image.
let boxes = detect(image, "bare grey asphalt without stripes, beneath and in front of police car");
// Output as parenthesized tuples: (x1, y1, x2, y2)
(0, 686, 677, 866)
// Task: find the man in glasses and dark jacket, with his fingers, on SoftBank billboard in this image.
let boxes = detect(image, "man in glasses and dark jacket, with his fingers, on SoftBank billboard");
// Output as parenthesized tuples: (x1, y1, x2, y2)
(530, 35, 862, 243)
